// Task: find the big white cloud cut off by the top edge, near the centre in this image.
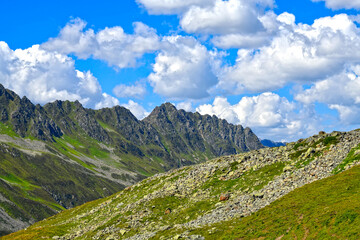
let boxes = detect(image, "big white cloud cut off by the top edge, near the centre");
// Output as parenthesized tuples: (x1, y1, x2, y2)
(137, 0, 274, 47)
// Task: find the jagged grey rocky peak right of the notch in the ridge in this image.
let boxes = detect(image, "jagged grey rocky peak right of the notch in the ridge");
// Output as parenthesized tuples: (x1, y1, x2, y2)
(143, 103, 262, 156)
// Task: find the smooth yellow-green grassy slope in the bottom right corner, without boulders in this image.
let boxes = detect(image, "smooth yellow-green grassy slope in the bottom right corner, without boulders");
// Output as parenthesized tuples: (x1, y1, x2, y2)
(192, 166, 360, 239)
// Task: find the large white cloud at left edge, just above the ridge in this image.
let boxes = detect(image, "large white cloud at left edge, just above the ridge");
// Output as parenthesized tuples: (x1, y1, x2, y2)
(0, 42, 119, 107)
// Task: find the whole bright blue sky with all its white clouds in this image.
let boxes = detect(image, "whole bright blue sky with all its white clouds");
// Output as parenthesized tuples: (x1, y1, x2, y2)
(0, 0, 360, 141)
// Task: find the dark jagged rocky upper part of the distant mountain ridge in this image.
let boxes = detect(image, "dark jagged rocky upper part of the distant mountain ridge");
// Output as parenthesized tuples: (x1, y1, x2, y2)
(0, 83, 263, 173)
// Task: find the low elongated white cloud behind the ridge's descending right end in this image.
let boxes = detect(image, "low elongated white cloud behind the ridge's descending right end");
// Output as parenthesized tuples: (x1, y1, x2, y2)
(196, 92, 318, 141)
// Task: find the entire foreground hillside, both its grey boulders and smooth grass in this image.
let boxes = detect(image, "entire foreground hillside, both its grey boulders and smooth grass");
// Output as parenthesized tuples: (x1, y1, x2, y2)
(4, 130, 360, 239)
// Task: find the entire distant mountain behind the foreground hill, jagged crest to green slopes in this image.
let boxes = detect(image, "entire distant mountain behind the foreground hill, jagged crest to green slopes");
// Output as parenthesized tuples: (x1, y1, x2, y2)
(0, 85, 262, 235)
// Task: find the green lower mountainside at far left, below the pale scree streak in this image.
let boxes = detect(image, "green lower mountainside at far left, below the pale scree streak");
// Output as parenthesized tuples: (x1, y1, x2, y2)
(0, 138, 124, 234)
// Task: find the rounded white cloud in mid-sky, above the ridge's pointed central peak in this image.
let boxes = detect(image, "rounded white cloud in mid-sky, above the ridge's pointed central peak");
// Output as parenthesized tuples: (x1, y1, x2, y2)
(148, 36, 217, 99)
